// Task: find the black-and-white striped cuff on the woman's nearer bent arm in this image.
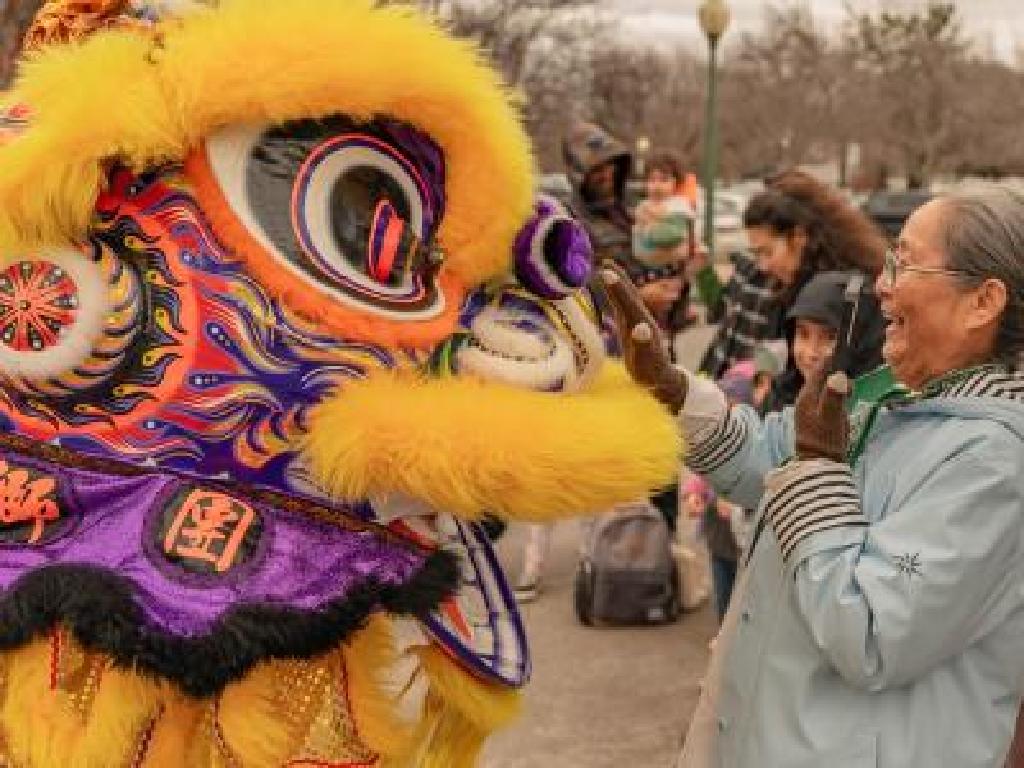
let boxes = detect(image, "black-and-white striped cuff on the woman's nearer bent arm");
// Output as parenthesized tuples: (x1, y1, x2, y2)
(765, 459, 867, 559)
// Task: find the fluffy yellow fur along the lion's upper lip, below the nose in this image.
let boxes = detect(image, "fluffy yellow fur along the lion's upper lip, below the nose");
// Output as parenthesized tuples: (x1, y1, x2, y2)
(305, 364, 681, 520)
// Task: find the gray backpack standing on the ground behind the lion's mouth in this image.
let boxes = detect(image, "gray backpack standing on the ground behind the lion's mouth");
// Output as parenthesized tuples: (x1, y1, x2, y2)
(573, 502, 680, 626)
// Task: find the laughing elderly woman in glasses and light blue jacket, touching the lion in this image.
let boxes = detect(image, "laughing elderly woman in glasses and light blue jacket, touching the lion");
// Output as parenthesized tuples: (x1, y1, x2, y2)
(606, 189, 1024, 768)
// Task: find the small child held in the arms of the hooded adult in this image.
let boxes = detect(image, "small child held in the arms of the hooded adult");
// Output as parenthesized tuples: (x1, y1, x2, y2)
(630, 155, 696, 332)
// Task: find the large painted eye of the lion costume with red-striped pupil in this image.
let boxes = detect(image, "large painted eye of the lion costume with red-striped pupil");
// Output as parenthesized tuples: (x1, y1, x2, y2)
(195, 117, 445, 321)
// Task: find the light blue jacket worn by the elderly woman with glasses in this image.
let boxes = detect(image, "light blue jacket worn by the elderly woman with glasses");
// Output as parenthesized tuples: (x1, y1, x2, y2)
(684, 382, 1024, 768)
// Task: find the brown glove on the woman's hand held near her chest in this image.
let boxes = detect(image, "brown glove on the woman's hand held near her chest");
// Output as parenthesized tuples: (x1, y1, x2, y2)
(795, 372, 851, 462)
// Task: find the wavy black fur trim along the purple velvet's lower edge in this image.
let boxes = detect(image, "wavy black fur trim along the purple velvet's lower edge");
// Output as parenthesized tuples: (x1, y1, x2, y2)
(0, 551, 459, 697)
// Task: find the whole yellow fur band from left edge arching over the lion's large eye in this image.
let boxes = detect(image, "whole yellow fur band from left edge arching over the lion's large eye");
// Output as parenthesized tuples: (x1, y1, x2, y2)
(0, 0, 534, 286)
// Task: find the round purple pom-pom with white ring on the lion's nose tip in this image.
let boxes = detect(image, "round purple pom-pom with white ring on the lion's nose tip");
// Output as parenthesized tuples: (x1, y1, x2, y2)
(513, 196, 593, 301)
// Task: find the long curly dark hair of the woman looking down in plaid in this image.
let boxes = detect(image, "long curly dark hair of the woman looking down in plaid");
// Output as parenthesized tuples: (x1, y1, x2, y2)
(743, 170, 886, 305)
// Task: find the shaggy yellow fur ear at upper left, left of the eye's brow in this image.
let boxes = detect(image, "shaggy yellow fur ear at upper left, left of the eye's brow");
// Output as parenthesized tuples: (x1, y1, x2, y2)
(0, 30, 174, 256)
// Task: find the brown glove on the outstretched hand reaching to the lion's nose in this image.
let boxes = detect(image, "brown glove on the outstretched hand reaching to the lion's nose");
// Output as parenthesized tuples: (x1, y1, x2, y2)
(600, 263, 686, 414)
